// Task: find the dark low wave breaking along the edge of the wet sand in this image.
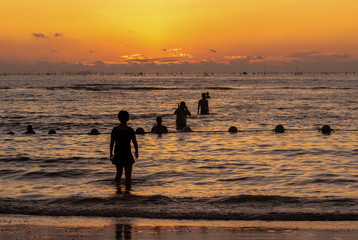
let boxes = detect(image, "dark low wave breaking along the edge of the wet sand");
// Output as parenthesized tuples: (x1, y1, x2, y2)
(0, 193, 358, 221)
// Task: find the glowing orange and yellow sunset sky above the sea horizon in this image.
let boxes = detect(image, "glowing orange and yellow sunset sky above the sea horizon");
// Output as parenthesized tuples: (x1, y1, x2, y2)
(0, 0, 358, 71)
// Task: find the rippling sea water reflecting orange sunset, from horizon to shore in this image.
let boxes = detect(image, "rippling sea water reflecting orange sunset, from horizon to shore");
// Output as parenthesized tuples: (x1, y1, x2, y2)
(0, 74, 358, 221)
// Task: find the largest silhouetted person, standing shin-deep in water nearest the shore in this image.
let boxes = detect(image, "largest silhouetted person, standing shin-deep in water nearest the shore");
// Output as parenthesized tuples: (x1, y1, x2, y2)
(109, 111, 138, 187)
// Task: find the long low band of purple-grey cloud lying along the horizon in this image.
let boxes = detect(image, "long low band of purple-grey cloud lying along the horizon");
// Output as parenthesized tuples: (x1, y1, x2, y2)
(0, 56, 358, 73)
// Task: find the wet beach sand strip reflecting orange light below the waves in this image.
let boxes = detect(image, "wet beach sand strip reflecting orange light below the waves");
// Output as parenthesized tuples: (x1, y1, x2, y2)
(0, 215, 358, 240)
